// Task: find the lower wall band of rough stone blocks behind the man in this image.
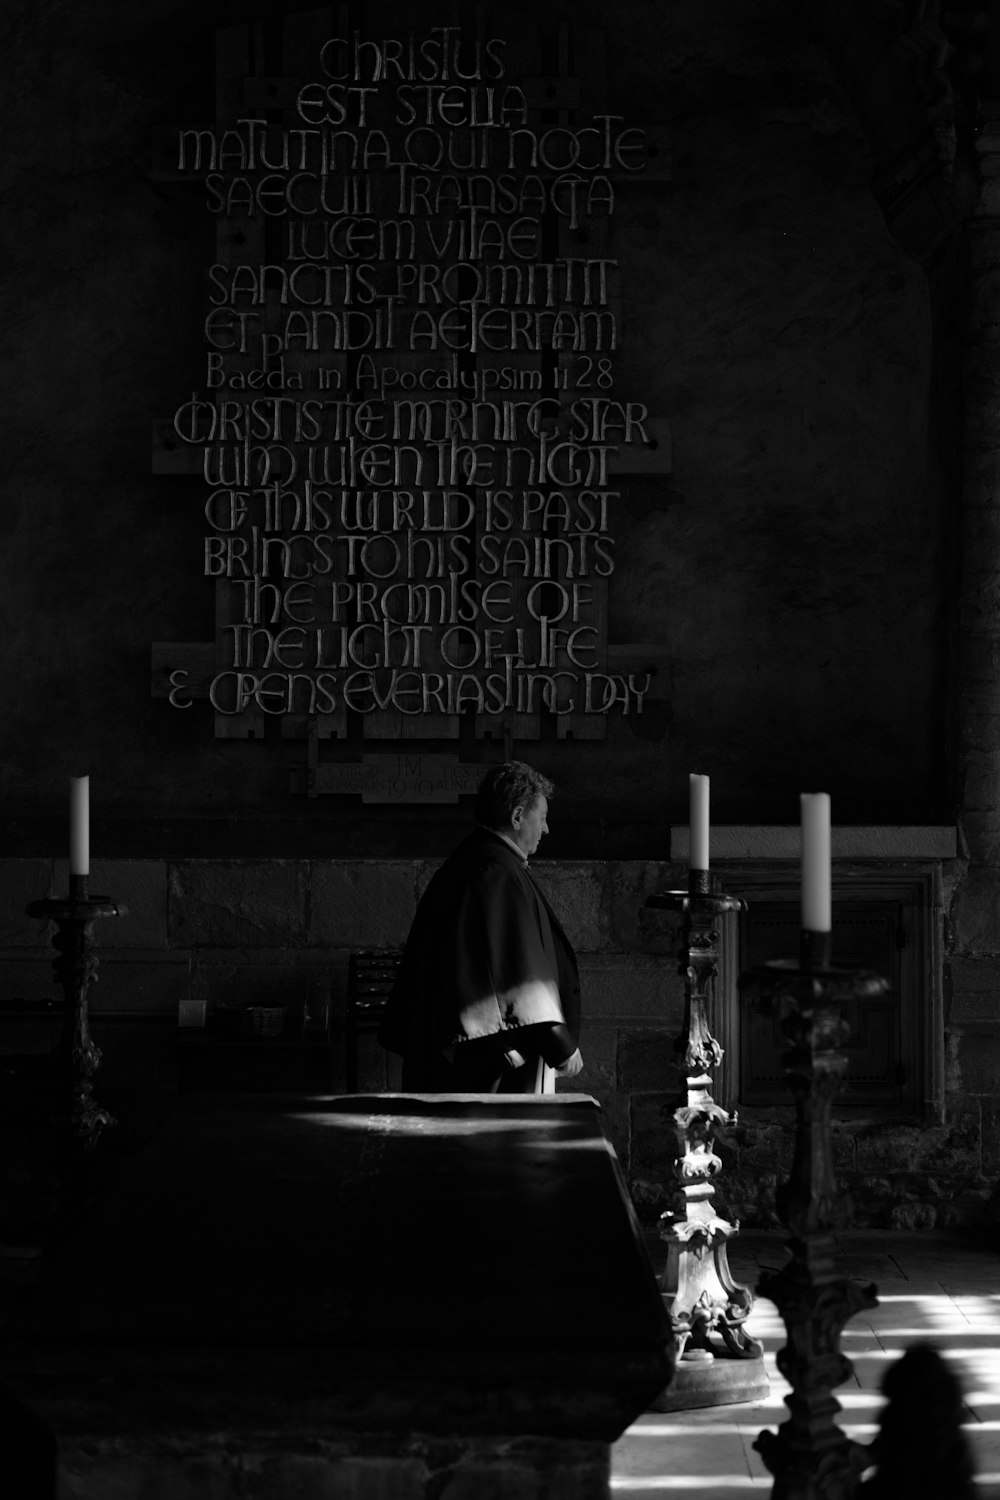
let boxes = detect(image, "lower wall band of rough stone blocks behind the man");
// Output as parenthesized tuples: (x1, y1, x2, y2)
(0, 860, 1000, 1229)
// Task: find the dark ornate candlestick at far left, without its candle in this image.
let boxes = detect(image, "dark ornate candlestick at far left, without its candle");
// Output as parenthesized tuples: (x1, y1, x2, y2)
(27, 875, 127, 1155)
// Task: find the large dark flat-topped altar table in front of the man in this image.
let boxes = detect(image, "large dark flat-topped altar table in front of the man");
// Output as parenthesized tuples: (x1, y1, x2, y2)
(0, 1094, 672, 1500)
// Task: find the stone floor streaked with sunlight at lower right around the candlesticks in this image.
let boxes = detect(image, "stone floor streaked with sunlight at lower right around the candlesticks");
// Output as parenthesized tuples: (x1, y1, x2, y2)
(612, 1232, 1000, 1500)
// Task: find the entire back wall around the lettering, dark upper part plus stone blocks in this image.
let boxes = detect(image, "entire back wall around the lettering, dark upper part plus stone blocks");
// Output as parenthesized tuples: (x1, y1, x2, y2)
(0, 0, 1000, 1226)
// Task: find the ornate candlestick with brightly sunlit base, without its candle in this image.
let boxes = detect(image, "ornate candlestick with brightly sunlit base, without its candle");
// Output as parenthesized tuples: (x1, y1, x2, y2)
(646, 870, 768, 1412)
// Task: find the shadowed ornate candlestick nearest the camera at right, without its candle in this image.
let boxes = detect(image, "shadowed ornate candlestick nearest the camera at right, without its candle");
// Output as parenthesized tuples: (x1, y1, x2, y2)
(741, 932, 888, 1500)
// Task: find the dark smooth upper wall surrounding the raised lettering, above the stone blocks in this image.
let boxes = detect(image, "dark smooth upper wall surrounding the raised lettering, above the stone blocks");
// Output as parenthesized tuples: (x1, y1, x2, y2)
(0, 0, 955, 858)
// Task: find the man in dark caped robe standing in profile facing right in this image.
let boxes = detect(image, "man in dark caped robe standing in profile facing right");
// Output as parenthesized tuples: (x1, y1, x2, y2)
(379, 761, 583, 1094)
